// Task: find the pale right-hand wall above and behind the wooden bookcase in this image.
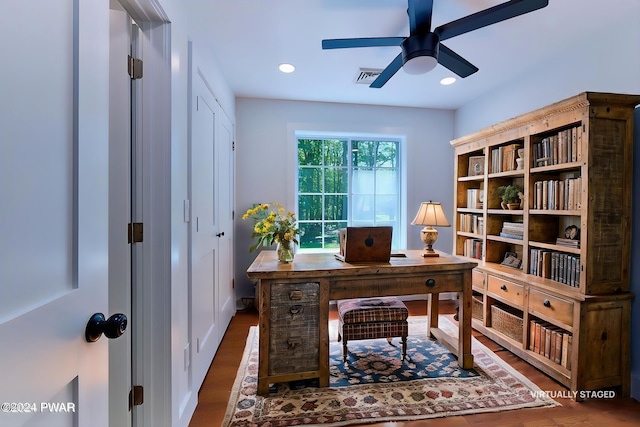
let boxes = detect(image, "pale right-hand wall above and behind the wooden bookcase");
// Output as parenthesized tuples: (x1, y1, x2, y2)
(455, 13, 640, 400)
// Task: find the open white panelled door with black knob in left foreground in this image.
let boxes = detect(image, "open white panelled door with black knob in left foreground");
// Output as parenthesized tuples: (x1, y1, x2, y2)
(0, 0, 109, 427)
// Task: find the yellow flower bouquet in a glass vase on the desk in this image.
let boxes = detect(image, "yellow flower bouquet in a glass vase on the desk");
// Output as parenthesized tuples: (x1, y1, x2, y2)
(242, 203, 300, 261)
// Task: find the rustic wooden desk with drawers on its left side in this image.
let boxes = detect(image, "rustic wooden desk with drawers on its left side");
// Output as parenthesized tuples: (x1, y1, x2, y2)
(247, 251, 477, 395)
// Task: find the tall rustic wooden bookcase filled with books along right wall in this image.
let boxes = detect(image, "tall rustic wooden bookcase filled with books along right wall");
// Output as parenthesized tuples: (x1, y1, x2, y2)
(451, 92, 640, 396)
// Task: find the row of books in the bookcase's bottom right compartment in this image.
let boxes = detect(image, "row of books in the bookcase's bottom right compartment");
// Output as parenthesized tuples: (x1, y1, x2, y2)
(529, 319, 573, 369)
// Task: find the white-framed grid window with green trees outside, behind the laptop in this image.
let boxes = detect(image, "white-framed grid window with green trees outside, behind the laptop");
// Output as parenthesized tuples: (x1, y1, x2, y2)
(297, 137, 402, 249)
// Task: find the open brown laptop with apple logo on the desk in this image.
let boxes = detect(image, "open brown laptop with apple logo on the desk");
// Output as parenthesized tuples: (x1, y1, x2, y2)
(336, 226, 393, 263)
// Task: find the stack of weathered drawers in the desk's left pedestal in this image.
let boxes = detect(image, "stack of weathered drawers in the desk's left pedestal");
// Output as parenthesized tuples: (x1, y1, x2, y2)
(269, 283, 320, 375)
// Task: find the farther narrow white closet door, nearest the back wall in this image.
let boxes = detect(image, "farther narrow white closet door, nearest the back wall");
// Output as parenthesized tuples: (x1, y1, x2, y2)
(216, 110, 236, 328)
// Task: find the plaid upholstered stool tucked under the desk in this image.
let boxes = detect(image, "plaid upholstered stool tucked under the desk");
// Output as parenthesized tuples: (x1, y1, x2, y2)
(338, 297, 409, 362)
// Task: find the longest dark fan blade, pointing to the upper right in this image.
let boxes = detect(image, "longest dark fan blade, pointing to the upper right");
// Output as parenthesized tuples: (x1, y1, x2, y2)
(433, 0, 549, 40)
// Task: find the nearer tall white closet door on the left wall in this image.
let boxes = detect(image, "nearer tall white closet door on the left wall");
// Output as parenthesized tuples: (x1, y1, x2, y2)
(189, 73, 220, 390)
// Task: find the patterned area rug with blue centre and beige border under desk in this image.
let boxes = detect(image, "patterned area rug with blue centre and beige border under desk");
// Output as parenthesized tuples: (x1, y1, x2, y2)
(222, 316, 558, 427)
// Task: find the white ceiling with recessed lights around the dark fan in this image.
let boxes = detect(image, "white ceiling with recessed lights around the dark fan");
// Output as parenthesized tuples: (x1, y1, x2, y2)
(190, 0, 640, 109)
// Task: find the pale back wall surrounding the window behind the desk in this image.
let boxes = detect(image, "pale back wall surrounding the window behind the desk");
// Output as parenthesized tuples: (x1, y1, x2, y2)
(235, 98, 453, 297)
